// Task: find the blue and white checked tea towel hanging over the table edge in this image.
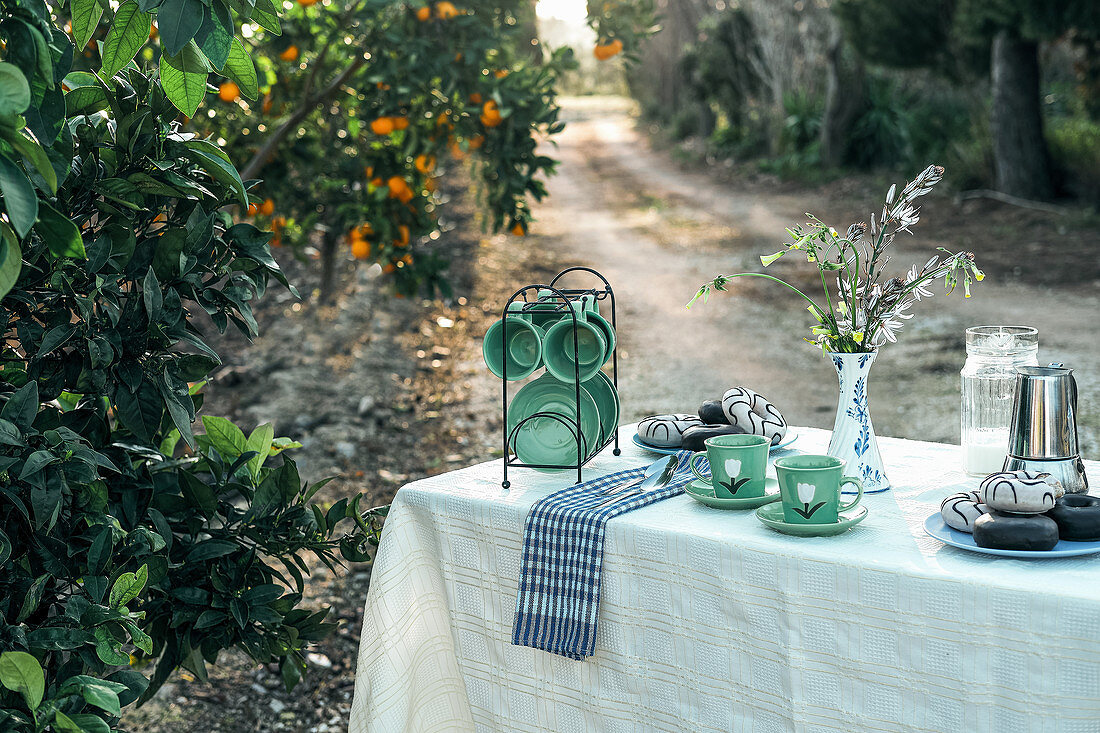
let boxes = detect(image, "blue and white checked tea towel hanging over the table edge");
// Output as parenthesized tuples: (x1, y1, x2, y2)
(512, 450, 695, 659)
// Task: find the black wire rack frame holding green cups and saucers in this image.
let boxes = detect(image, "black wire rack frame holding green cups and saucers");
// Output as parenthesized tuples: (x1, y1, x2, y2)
(501, 267, 623, 489)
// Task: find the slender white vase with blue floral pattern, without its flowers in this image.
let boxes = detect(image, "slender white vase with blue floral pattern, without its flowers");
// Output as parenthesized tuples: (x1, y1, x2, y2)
(828, 353, 890, 494)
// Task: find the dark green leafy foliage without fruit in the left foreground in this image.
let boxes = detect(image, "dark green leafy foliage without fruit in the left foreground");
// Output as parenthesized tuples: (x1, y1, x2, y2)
(0, 0, 396, 733)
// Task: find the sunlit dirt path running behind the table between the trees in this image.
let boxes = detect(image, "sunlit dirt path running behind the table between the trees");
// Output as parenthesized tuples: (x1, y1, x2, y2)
(510, 98, 1100, 457)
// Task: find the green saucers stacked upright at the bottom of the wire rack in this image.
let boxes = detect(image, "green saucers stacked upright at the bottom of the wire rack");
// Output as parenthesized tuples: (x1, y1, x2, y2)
(507, 372, 619, 466)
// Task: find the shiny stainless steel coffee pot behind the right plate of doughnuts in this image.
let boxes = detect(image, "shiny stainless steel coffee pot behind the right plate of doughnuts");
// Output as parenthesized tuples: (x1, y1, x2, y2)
(1004, 364, 1089, 494)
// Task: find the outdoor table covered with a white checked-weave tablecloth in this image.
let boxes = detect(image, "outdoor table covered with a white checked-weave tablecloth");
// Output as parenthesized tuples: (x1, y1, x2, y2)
(349, 426, 1100, 733)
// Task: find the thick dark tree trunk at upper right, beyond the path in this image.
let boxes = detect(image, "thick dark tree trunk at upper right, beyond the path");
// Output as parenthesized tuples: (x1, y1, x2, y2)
(990, 31, 1053, 199)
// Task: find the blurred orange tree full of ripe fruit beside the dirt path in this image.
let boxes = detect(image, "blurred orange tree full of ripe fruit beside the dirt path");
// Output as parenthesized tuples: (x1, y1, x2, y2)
(193, 0, 651, 294)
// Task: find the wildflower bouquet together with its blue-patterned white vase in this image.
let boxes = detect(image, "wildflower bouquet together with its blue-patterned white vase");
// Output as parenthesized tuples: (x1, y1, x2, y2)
(688, 165, 985, 493)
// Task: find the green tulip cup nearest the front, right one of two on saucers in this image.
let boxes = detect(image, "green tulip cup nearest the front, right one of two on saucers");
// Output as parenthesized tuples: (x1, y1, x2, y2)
(776, 455, 864, 524)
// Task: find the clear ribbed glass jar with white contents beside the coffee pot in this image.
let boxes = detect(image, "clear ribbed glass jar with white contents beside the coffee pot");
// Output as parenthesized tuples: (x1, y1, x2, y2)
(960, 326, 1038, 475)
